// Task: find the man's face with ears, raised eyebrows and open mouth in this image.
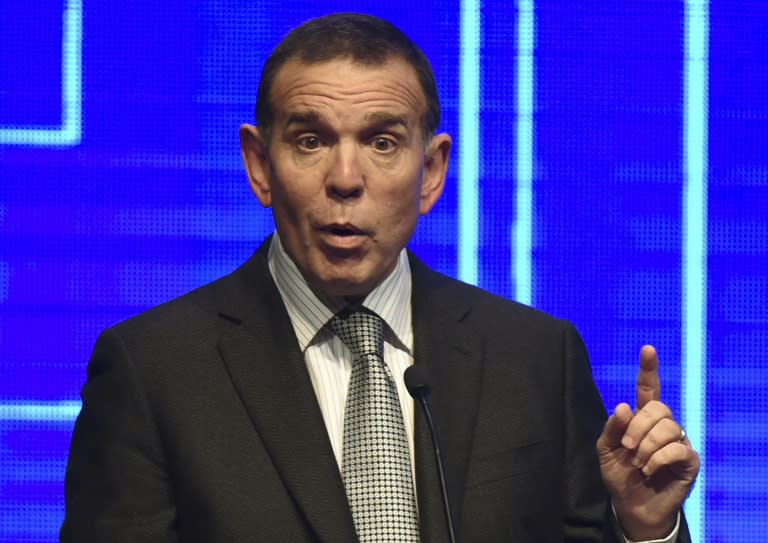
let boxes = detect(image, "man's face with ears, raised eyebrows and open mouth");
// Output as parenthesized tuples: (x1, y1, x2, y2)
(240, 58, 451, 305)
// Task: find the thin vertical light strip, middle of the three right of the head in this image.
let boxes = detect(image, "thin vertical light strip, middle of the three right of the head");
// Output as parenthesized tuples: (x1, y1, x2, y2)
(512, 0, 536, 305)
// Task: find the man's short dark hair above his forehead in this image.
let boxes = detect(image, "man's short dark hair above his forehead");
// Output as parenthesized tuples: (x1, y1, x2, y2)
(256, 13, 440, 140)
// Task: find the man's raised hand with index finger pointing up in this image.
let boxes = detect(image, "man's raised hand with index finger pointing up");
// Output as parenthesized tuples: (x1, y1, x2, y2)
(597, 345, 699, 541)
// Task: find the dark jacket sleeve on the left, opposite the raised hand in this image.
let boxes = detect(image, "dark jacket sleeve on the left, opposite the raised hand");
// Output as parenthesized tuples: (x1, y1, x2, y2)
(59, 329, 177, 543)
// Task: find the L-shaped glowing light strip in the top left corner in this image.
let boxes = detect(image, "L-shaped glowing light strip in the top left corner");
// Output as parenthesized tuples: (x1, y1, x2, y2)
(0, 0, 83, 147)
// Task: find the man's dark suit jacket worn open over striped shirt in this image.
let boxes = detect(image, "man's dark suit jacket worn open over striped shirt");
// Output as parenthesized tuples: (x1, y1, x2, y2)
(61, 243, 692, 543)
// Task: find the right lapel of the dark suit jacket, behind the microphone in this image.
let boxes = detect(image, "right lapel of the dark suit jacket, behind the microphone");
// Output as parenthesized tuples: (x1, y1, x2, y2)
(411, 256, 482, 543)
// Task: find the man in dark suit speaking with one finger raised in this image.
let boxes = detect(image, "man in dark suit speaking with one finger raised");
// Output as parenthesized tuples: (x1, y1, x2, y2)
(61, 14, 698, 542)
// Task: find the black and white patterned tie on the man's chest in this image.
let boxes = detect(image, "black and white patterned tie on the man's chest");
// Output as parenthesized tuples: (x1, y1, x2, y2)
(330, 311, 419, 543)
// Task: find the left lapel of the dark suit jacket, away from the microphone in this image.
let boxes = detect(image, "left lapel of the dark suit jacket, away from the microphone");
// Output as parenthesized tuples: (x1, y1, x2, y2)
(210, 246, 356, 542)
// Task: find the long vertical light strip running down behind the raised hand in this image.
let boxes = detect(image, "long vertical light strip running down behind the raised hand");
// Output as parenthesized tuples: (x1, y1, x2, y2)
(681, 0, 709, 542)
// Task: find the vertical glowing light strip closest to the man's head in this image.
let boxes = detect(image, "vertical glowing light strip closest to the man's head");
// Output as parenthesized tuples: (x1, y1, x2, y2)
(458, 0, 481, 285)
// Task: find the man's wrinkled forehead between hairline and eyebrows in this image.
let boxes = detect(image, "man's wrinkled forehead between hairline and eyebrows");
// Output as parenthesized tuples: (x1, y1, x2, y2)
(270, 57, 426, 122)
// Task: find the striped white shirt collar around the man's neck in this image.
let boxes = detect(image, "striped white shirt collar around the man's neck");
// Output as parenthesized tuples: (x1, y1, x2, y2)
(268, 232, 413, 353)
